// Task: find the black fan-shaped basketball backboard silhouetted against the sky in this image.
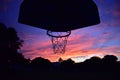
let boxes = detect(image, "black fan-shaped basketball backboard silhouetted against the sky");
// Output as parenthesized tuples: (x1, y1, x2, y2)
(18, 0, 100, 53)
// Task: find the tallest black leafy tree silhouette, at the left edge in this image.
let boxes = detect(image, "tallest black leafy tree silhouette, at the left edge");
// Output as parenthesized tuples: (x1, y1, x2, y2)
(0, 23, 25, 63)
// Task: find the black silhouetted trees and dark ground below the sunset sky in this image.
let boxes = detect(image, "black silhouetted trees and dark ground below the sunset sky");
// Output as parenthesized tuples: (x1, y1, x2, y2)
(0, 23, 120, 80)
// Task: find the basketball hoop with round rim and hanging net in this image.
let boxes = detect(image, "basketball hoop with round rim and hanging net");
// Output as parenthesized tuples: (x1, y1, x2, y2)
(47, 30, 71, 54)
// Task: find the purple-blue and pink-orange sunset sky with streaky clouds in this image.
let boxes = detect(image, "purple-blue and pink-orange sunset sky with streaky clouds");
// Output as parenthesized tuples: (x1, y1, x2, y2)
(0, 0, 120, 62)
